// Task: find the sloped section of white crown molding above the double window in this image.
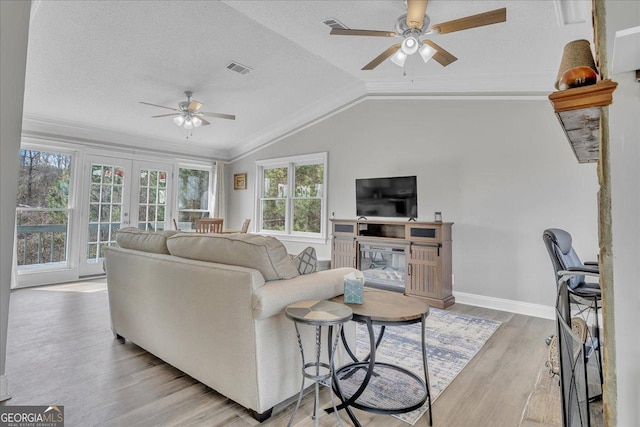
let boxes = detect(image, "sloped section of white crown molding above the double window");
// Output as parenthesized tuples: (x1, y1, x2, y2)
(228, 81, 367, 161)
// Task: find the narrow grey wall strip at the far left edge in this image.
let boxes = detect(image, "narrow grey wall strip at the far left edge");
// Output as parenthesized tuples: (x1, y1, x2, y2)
(0, 1, 31, 400)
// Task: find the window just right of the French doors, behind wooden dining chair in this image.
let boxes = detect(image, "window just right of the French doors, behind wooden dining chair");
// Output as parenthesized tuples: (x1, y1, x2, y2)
(178, 167, 213, 230)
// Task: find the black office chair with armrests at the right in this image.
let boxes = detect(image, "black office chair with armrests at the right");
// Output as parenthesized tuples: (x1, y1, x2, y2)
(542, 228, 603, 400)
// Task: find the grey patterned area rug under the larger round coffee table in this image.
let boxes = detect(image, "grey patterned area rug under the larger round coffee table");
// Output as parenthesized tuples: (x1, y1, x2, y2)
(338, 308, 500, 425)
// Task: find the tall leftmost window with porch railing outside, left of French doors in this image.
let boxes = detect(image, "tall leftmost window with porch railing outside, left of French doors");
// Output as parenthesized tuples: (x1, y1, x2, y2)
(16, 149, 71, 270)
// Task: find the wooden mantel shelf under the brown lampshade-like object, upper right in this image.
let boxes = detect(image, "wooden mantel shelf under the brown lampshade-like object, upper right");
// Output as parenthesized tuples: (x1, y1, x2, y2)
(549, 80, 618, 163)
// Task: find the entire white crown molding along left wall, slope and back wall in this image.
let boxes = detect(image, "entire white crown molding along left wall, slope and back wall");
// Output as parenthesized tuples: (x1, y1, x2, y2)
(23, 73, 553, 163)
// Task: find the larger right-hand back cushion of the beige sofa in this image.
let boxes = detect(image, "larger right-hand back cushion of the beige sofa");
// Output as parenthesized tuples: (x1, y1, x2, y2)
(167, 233, 298, 281)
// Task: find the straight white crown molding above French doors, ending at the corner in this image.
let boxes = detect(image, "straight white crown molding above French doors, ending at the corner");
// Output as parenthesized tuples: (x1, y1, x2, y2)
(22, 114, 227, 160)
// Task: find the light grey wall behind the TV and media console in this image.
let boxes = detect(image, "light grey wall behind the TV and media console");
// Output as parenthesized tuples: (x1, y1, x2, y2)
(227, 99, 598, 306)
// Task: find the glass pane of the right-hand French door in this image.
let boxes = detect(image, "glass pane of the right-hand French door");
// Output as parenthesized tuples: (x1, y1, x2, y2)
(138, 169, 167, 231)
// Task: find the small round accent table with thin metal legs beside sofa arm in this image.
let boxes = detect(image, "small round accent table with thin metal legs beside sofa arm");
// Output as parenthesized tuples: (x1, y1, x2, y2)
(284, 301, 353, 426)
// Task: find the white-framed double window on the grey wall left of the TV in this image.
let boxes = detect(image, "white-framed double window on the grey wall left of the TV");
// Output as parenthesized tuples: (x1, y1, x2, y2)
(256, 153, 327, 238)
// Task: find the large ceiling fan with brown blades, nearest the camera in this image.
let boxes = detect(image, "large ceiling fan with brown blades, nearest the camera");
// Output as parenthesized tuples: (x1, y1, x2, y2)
(331, 0, 507, 70)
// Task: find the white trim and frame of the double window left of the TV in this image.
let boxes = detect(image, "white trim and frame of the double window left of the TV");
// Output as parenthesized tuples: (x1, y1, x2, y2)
(255, 151, 328, 244)
